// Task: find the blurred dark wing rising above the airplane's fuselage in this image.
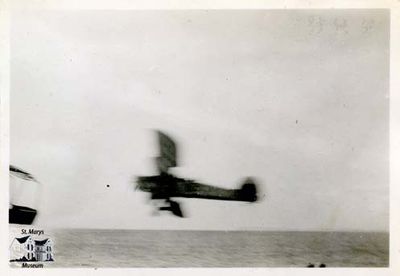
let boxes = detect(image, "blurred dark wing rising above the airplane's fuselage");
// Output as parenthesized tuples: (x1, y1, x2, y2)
(157, 131, 177, 173)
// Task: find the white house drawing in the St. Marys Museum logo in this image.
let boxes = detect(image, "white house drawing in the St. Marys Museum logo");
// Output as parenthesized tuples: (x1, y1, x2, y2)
(10, 235, 54, 267)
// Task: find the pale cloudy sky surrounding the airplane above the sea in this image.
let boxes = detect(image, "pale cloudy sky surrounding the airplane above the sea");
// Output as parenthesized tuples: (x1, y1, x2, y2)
(10, 10, 389, 231)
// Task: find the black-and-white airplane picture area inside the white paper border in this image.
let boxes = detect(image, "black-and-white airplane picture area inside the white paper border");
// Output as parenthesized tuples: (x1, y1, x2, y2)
(8, 9, 390, 269)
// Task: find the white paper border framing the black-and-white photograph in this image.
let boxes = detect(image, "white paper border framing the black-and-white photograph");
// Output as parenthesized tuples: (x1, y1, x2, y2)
(0, 0, 400, 276)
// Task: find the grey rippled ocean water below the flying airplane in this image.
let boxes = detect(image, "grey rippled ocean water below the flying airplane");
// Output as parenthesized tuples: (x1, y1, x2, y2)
(21, 229, 389, 267)
